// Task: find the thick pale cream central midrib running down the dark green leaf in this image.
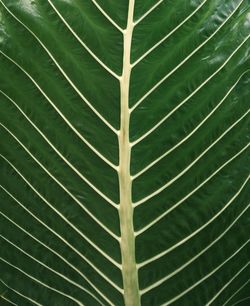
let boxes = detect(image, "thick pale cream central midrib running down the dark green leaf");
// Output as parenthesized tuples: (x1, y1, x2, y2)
(118, 0, 140, 306)
